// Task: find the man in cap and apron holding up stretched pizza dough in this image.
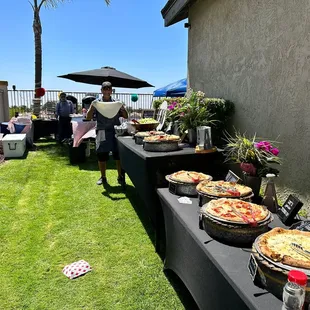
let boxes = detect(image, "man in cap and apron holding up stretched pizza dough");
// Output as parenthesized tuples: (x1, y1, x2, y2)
(86, 82, 128, 185)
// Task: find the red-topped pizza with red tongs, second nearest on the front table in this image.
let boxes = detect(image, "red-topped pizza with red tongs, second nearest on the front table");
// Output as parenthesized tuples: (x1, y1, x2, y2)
(204, 198, 270, 226)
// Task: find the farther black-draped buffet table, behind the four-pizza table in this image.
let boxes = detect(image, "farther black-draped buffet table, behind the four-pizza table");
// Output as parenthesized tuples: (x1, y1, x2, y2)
(118, 137, 227, 252)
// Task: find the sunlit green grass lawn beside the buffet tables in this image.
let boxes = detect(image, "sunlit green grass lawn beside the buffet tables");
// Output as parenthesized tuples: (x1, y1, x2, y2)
(0, 143, 184, 310)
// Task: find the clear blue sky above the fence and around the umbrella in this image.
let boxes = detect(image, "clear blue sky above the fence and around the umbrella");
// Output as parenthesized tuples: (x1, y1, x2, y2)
(0, 0, 187, 93)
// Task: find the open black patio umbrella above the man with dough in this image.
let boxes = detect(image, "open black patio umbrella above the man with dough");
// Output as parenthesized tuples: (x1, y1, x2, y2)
(58, 67, 154, 88)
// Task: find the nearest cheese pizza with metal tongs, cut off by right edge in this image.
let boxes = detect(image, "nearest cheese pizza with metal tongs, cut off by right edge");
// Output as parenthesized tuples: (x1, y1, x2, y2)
(257, 227, 310, 269)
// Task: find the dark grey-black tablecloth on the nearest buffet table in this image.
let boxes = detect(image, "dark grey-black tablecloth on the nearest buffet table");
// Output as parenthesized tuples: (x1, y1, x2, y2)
(157, 189, 284, 310)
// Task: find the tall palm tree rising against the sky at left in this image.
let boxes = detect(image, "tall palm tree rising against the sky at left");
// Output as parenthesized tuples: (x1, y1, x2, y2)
(28, 0, 110, 97)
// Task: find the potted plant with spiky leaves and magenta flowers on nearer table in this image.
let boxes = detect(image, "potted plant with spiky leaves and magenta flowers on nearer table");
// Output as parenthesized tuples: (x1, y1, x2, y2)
(224, 132, 281, 197)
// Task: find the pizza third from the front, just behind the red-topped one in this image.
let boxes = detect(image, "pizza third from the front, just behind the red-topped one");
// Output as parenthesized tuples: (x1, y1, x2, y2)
(196, 181, 252, 198)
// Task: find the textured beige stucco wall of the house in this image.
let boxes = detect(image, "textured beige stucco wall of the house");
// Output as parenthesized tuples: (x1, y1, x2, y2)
(188, 0, 310, 211)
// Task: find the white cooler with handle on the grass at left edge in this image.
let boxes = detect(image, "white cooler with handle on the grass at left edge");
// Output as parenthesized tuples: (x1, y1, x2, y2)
(2, 133, 26, 158)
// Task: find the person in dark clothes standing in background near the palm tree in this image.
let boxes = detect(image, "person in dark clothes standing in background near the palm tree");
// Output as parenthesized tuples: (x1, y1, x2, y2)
(56, 92, 74, 142)
